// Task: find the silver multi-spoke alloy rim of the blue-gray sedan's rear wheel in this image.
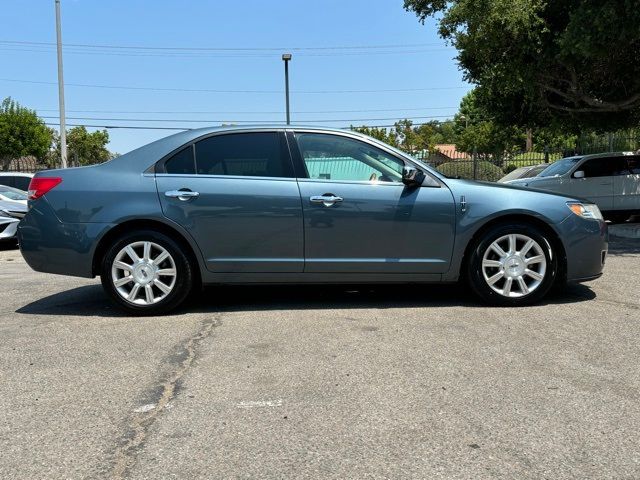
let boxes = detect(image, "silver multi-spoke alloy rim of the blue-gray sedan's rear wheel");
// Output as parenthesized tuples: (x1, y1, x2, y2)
(111, 241, 177, 305)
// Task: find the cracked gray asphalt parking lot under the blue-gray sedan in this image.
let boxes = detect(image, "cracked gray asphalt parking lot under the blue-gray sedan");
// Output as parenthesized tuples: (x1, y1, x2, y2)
(0, 234, 640, 479)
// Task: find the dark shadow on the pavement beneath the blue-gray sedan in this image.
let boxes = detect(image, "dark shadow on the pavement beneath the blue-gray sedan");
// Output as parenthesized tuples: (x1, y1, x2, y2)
(16, 284, 596, 317)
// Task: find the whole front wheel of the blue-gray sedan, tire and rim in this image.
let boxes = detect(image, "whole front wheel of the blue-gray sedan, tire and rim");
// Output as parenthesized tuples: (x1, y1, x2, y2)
(467, 224, 558, 306)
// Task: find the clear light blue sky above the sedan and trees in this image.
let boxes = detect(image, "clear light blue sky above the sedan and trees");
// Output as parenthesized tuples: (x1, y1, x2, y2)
(0, 0, 470, 153)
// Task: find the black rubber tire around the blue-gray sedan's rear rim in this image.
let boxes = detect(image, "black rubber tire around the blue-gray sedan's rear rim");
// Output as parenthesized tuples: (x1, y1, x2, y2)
(100, 230, 195, 316)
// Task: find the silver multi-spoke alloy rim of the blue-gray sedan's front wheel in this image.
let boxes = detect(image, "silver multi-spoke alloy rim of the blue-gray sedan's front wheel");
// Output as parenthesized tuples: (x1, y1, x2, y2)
(482, 233, 547, 298)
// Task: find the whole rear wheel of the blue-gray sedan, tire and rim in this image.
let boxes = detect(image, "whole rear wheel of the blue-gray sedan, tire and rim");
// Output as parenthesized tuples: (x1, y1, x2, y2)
(100, 230, 193, 315)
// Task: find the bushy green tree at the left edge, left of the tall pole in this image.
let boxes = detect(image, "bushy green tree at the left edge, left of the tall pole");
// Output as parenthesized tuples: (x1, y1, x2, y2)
(0, 98, 51, 170)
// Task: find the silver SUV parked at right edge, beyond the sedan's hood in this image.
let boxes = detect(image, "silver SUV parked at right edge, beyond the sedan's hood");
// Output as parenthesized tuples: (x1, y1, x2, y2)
(510, 152, 640, 221)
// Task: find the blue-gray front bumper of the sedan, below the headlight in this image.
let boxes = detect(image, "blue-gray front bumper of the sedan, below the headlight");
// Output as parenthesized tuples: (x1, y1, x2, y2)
(559, 215, 609, 282)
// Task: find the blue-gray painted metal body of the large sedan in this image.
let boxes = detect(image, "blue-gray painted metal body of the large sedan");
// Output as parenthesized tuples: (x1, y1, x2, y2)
(19, 126, 607, 284)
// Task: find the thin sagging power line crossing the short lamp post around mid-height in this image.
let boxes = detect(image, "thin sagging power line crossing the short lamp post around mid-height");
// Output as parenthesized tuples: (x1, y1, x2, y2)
(0, 78, 467, 95)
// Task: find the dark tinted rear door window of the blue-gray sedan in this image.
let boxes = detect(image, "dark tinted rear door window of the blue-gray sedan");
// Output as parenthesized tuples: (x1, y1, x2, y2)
(196, 132, 293, 177)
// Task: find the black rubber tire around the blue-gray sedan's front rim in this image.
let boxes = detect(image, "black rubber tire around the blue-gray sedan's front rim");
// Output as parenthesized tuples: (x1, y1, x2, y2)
(466, 223, 558, 307)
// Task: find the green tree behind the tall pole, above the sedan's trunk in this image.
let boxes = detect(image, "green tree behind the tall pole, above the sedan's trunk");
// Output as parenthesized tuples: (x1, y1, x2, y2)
(54, 127, 114, 165)
